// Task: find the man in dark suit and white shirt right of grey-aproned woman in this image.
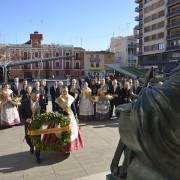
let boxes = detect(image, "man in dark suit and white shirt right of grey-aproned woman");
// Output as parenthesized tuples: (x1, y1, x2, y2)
(109, 79, 121, 118)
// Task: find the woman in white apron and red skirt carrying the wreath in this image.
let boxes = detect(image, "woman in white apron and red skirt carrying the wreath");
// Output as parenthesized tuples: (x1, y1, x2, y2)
(43, 86, 84, 153)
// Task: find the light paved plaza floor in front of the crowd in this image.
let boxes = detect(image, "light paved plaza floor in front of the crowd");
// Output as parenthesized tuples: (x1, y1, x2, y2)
(0, 102, 119, 180)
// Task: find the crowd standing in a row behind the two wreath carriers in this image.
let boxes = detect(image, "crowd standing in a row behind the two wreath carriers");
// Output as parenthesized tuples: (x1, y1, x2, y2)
(0, 77, 145, 126)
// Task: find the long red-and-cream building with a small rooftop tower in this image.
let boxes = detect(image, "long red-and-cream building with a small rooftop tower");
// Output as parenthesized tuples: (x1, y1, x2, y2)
(0, 32, 85, 78)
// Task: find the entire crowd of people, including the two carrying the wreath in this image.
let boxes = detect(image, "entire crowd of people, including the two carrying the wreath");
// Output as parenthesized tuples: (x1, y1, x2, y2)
(0, 77, 148, 163)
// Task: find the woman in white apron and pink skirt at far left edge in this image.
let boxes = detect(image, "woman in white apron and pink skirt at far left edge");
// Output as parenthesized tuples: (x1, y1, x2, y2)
(0, 83, 20, 127)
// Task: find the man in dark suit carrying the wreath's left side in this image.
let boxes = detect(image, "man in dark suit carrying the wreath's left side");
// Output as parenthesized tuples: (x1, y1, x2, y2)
(22, 91, 41, 163)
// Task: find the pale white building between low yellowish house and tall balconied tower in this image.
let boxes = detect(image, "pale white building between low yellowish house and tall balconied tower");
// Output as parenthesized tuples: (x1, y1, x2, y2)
(110, 36, 137, 66)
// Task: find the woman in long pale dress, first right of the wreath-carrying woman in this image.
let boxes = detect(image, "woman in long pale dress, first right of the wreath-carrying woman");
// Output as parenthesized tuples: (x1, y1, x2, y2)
(79, 82, 94, 120)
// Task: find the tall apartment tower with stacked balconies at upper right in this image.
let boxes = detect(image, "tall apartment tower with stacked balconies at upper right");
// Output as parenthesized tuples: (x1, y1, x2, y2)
(135, 0, 180, 72)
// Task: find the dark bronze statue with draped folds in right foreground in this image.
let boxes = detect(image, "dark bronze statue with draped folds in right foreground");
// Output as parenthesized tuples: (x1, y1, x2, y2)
(109, 66, 180, 180)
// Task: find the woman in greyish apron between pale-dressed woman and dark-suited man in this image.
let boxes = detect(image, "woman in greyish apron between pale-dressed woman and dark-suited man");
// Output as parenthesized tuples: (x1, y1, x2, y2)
(96, 86, 110, 120)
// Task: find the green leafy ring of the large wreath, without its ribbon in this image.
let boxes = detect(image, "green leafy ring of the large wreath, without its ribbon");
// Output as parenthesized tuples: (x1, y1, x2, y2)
(29, 112, 71, 151)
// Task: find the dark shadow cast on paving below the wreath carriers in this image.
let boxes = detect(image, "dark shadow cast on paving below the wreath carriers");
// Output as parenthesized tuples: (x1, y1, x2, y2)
(0, 151, 69, 173)
